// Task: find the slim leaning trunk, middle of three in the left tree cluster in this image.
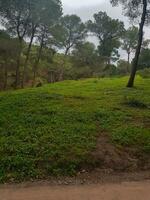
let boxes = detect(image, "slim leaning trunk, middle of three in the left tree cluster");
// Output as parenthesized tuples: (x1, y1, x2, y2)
(22, 27, 36, 88)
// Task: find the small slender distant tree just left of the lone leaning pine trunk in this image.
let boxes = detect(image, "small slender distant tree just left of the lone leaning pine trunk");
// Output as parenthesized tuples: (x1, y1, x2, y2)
(122, 26, 138, 72)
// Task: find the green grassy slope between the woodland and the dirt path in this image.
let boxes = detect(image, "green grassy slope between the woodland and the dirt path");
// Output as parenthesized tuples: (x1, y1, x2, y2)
(0, 77, 150, 181)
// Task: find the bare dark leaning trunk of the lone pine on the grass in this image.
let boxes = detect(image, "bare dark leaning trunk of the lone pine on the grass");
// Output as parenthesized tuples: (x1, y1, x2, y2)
(127, 0, 147, 88)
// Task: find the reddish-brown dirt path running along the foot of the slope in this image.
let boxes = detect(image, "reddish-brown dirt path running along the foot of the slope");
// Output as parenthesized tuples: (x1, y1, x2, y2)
(0, 181, 150, 200)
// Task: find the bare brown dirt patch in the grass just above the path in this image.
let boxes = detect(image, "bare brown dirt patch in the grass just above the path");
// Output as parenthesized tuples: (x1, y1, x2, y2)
(85, 133, 150, 172)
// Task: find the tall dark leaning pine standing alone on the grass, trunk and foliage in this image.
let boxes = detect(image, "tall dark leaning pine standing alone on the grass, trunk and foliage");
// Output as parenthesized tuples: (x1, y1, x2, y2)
(111, 0, 150, 87)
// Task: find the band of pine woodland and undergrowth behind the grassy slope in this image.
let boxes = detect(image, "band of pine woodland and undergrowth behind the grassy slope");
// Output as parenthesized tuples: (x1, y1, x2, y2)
(0, 0, 150, 90)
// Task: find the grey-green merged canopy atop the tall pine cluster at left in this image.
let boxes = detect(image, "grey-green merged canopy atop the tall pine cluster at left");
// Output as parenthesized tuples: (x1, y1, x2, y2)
(0, 0, 62, 39)
